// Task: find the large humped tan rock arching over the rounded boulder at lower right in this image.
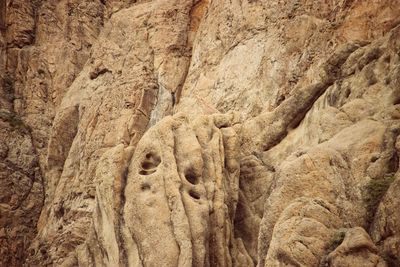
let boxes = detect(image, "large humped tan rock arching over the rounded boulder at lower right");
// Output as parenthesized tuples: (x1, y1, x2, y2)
(258, 121, 385, 264)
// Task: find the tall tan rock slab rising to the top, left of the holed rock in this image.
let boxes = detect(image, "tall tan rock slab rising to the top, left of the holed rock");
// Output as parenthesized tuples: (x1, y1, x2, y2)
(26, 1, 197, 264)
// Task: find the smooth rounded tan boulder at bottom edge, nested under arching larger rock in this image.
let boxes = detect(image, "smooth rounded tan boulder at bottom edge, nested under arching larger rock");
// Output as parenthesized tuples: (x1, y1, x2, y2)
(264, 197, 342, 266)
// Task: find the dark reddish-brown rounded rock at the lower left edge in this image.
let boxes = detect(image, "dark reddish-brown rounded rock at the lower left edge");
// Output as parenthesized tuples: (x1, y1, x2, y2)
(0, 111, 44, 266)
